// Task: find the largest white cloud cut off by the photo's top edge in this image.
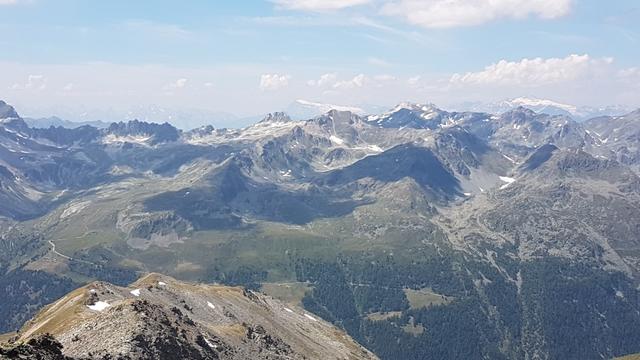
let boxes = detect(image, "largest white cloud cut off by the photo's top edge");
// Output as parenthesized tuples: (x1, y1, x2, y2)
(381, 0, 573, 28)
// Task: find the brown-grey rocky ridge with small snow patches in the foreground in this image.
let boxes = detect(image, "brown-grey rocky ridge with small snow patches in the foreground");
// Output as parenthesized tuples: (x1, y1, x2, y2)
(5, 274, 376, 360)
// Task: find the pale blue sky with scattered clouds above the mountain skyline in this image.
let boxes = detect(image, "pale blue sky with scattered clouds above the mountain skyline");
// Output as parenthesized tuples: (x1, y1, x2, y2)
(0, 0, 640, 126)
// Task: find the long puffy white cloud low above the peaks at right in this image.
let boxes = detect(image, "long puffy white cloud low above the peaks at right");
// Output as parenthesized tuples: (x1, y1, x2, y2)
(450, 54, 613, 86)
